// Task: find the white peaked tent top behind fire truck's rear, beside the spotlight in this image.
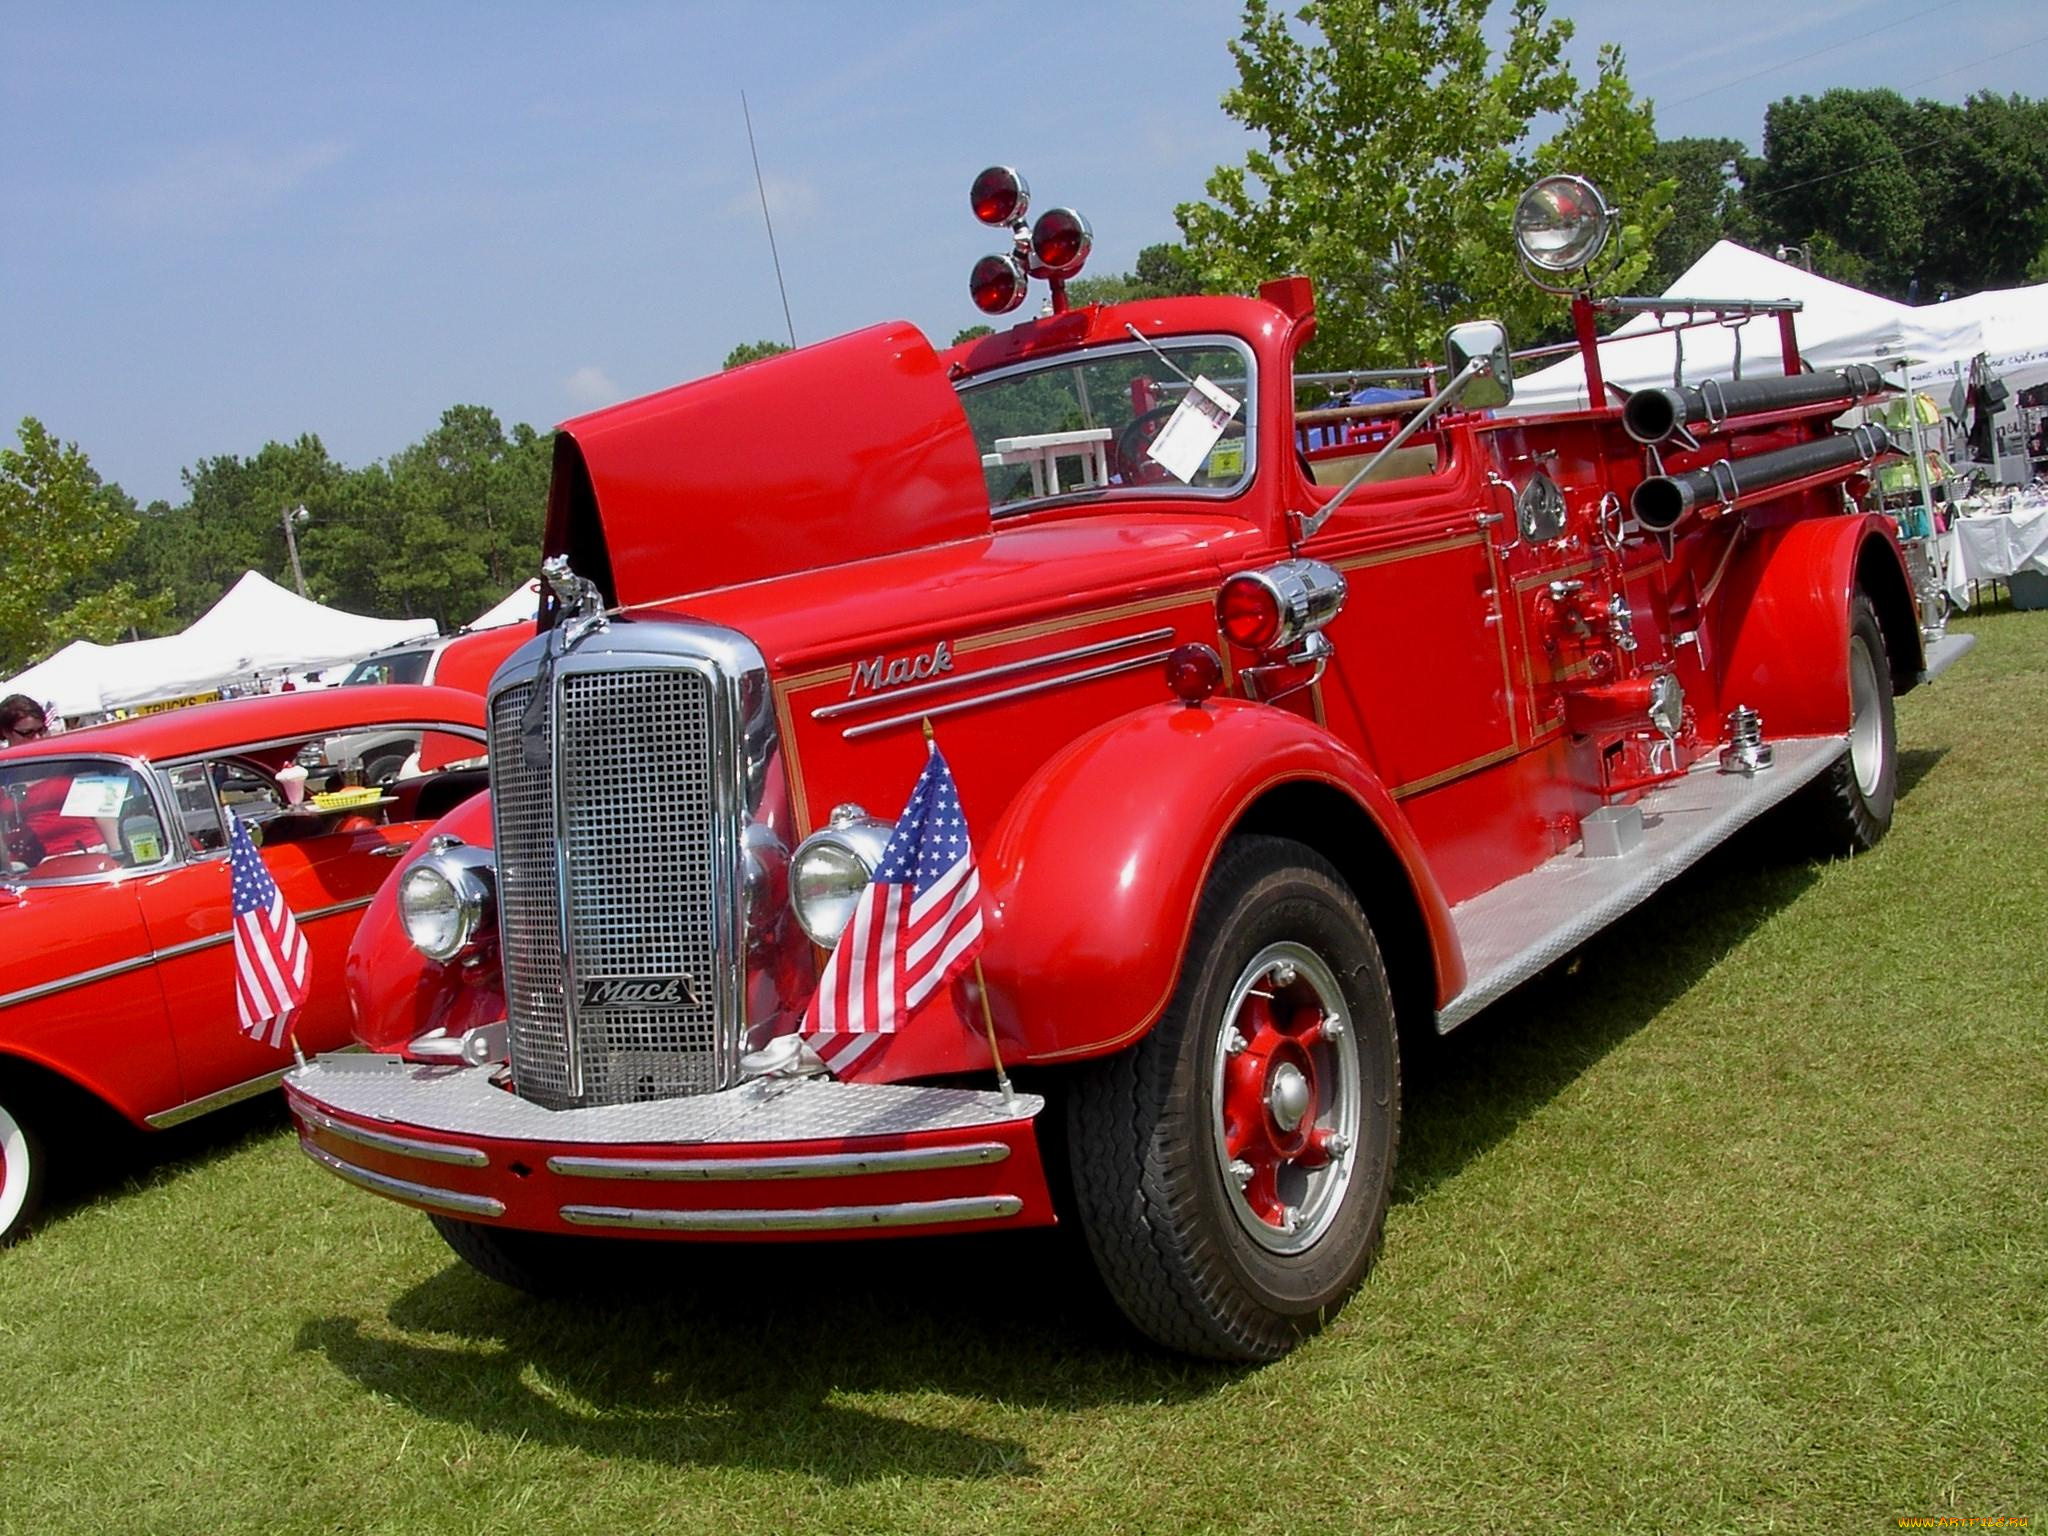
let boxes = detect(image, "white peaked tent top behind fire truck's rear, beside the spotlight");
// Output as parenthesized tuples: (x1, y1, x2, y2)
(1513, 240, 1916, 412)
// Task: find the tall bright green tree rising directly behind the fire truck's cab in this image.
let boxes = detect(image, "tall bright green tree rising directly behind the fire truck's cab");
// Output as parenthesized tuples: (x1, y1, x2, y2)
(1178, 0, 1667, 367)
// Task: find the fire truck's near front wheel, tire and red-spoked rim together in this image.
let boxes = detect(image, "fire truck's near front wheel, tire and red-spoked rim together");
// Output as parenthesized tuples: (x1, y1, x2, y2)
(1067, 836, 1401, 1362)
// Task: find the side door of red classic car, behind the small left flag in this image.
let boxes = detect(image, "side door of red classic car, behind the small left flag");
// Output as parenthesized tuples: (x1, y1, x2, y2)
(143, 758, 418, 1106)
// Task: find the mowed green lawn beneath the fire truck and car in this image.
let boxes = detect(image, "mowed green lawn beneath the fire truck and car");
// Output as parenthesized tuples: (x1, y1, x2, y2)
(0, 608, 2048, 1536)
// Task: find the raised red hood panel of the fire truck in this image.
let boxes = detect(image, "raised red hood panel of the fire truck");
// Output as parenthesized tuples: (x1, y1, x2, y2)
(547, 322, 989, 604)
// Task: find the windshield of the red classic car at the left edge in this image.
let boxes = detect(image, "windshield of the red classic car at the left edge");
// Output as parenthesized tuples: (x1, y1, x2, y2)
(0, 758, 170, 883)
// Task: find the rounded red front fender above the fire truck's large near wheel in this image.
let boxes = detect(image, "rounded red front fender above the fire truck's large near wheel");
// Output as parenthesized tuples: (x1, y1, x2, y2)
(981, 700, 1464, 1061)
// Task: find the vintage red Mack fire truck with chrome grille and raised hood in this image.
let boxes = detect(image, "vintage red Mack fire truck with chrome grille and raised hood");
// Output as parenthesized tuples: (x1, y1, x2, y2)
(287, 168, 1966, 1360)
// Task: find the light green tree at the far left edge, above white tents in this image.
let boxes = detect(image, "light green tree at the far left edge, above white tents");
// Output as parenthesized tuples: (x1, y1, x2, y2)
(0, 416, 166, 672)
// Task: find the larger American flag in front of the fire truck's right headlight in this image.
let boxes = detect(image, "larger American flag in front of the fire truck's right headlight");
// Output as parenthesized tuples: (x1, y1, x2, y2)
(803, 745, 981, 1073)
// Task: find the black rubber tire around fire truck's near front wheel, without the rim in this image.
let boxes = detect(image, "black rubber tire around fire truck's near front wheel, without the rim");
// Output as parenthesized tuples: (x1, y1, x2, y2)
(1067, 836, 1401, 1362)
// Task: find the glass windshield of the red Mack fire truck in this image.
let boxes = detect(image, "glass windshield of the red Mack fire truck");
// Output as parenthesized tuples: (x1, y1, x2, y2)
(961, 338, 1251, 514)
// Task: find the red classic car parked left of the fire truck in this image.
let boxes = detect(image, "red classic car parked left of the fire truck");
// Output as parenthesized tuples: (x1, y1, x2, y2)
(0, 688, 483, 1243)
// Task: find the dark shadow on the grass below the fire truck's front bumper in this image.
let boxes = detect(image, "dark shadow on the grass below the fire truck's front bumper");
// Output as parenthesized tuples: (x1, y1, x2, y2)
(297, 1233, 1235, 1483)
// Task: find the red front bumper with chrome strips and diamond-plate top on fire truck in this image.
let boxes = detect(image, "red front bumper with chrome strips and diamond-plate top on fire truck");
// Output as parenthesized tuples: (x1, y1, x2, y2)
(285, 1055, 1053, 1241)
